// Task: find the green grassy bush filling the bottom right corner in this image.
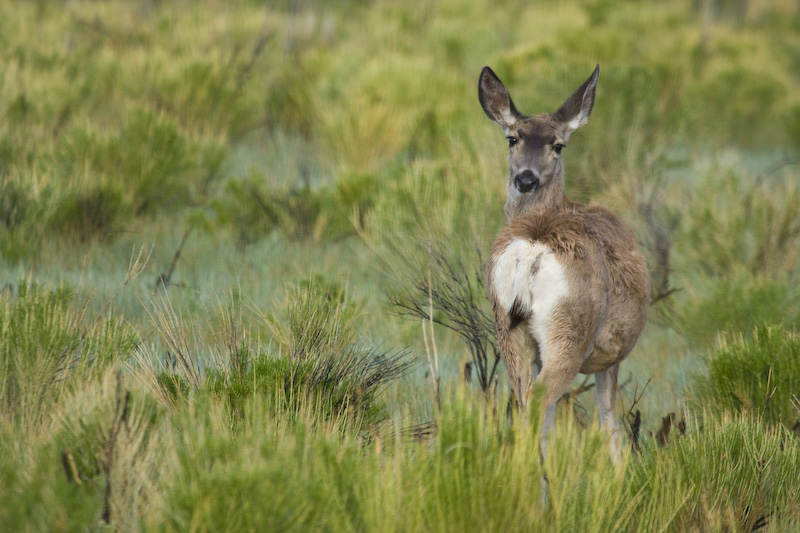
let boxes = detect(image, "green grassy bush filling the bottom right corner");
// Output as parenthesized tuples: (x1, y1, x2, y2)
(626, 416, 800, 531)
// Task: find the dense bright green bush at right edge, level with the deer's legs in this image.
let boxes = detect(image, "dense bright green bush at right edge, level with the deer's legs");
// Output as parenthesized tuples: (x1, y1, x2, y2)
(687, 325, 800, 427)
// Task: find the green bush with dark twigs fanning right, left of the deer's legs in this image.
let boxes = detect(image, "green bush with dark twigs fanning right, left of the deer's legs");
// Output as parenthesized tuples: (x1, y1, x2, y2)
(203, 278, 412, 428)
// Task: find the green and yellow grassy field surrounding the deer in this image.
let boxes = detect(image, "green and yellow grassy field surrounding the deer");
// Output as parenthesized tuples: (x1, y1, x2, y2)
(0, 0, 800, 532)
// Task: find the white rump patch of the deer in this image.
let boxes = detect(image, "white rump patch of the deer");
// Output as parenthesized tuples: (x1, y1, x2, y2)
(492, 239, 569, 358)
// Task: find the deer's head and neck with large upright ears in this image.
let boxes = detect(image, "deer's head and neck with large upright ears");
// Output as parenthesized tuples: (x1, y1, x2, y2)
(478, 65, 600, 220)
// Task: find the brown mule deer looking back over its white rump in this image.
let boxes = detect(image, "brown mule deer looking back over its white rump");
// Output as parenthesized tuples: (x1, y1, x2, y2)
(478, 65, 650, 460)
